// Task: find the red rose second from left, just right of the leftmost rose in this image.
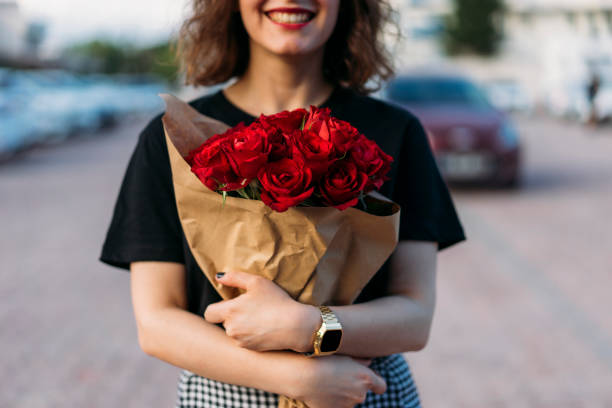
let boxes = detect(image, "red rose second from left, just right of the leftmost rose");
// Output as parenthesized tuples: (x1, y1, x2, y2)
(223, 122, 270, 180)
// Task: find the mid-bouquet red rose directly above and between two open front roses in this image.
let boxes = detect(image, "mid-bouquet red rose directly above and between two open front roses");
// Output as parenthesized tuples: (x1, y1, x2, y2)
(292, 129, 335, 183)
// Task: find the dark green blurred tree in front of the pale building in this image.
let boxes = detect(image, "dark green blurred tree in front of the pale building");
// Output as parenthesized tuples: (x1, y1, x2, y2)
(443, 0, 505, 56)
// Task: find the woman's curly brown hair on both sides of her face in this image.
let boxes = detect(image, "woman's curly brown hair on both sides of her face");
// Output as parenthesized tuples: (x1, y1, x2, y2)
(177, 0, 394, 94)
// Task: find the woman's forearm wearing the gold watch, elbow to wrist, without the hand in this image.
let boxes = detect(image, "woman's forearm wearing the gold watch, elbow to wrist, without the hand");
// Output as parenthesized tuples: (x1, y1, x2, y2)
(300, 295, 433, 357)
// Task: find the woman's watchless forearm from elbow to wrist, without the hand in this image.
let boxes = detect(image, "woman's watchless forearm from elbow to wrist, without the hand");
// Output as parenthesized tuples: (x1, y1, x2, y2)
(139, 308, 306, 397)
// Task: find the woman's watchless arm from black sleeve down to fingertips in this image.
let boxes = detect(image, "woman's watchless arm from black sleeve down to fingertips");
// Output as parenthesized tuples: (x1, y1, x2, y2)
(130, 262, 386, 407)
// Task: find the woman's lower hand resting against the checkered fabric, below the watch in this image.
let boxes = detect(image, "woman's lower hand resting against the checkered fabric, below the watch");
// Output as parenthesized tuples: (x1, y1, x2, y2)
(297, 354, 387, 408)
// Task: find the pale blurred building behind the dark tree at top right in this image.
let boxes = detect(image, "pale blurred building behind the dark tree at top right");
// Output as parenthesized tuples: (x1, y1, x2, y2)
(393, 0, 612, 107)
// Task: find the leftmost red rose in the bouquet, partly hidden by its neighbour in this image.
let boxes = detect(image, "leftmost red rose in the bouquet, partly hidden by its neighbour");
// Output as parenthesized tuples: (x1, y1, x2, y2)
(188, 129, 248, 191)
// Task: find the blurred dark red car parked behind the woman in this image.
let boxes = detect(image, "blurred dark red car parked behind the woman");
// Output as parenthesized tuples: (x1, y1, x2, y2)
(383, 74, 521, 187)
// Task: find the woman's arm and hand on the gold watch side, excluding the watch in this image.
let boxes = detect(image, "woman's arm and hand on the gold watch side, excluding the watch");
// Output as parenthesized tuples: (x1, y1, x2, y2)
(204, 241, 437, 357)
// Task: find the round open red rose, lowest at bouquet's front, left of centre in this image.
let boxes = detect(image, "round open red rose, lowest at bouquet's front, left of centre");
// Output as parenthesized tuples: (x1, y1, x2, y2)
(257, 158, 314, 212)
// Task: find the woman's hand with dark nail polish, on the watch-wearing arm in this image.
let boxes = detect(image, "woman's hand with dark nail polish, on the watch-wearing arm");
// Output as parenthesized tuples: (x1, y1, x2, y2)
(204, 271, 321, 352)
